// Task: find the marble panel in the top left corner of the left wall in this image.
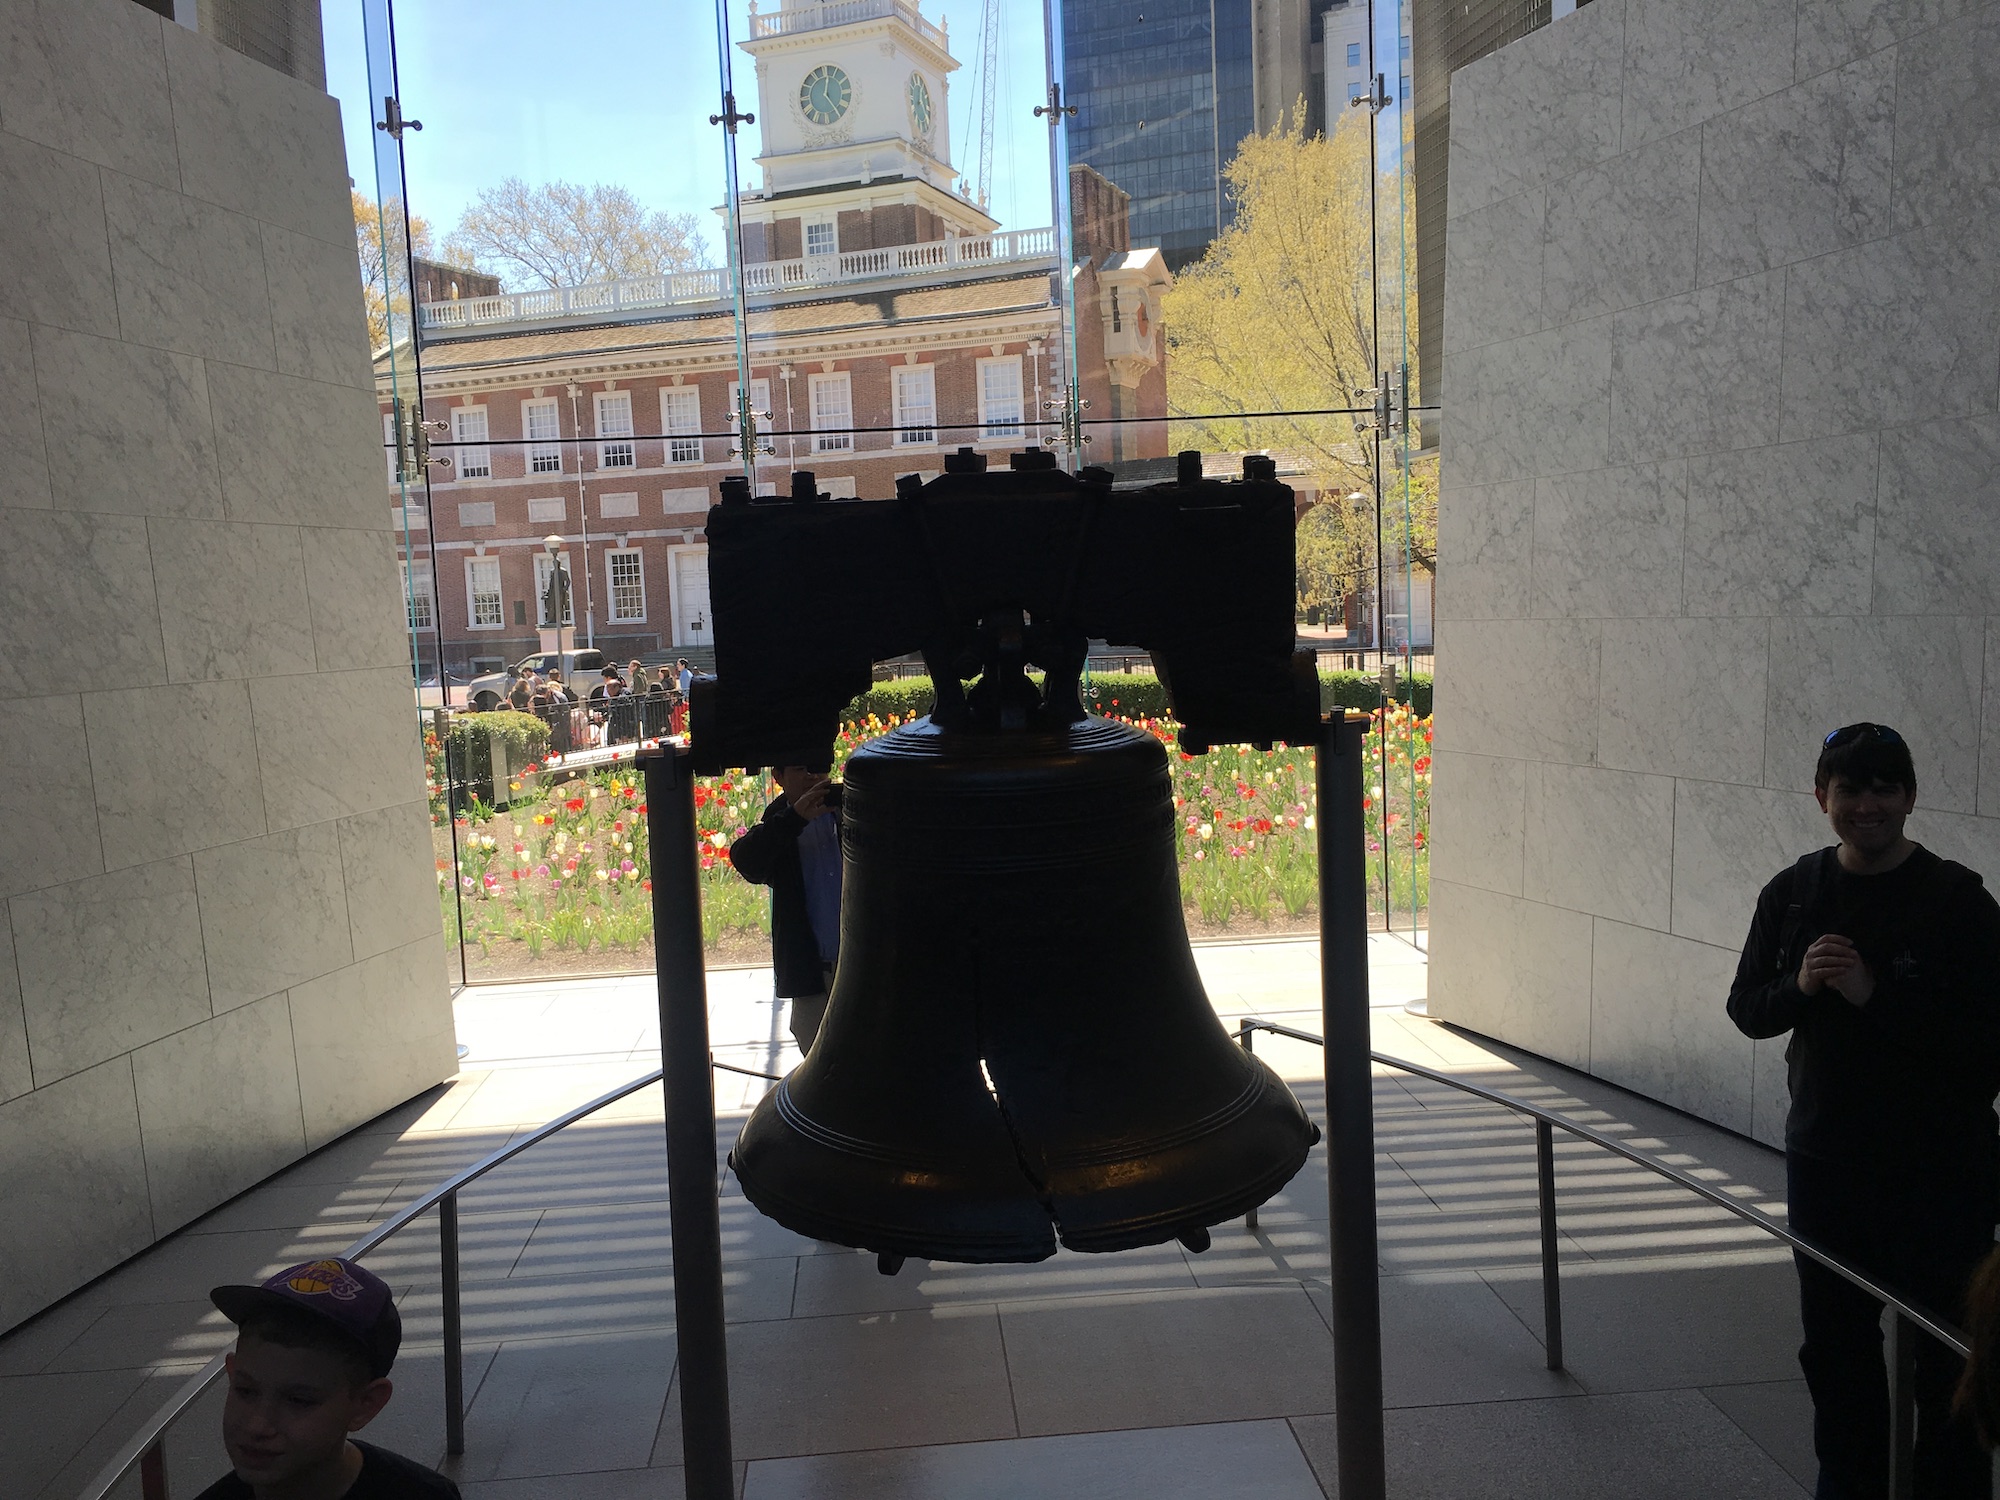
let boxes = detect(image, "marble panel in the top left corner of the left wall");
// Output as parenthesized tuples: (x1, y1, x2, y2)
(0, 0, 180, 188)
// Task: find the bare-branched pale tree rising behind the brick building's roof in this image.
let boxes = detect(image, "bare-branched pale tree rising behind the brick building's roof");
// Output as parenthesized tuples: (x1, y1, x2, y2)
(444, 178, 708, 290)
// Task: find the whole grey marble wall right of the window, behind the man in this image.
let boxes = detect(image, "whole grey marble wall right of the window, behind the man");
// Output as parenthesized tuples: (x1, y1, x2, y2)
(1430, 0, 2000, 1142)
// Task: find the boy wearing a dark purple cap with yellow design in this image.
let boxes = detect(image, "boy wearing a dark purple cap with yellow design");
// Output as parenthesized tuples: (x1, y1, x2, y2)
(196, 1258, 458, 1500)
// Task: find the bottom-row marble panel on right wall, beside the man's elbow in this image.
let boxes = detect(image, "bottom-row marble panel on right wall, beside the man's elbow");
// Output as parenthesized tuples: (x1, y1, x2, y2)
(1590, 920, 1756, 1134)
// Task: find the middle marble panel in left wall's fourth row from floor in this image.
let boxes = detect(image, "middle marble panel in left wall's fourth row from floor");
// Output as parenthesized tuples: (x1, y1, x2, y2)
(148, 520, 314, 682)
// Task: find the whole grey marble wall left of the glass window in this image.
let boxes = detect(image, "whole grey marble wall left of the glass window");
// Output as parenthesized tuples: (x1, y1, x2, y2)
(0, 0, 456, 1330)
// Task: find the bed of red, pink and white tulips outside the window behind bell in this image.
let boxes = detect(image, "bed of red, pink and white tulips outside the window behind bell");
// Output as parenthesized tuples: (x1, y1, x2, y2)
(434, 704, 1430, 970)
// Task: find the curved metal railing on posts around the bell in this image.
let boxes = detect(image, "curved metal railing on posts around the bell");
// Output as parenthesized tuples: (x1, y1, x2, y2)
(78, 1018, 1968, 1500)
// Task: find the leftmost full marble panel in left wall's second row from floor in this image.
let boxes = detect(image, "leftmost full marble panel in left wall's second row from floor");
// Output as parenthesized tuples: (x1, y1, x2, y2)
(8, 860, 208, 1088)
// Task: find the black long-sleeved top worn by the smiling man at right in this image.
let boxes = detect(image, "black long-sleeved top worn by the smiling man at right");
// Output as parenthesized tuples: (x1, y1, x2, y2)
(1728, 848, 2000, 1176)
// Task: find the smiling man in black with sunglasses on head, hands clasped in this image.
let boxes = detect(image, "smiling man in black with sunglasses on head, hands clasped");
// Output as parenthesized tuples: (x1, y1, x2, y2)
(1728, 724, 2000, 1500)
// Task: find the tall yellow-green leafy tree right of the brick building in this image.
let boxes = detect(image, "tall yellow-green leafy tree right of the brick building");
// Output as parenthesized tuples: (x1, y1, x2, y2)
(1160, 102, 1436, 608)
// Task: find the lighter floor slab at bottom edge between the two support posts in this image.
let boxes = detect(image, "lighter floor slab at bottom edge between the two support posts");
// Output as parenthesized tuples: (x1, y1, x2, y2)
(744, 1422, 1322, 1500)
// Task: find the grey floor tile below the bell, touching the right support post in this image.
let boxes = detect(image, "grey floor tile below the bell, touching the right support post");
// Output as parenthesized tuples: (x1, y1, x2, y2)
(1000, 1284, 1334, 1436)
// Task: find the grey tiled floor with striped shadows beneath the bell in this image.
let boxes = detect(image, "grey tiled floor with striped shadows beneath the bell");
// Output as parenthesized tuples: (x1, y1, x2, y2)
(0, 938, 1810, 1500)
